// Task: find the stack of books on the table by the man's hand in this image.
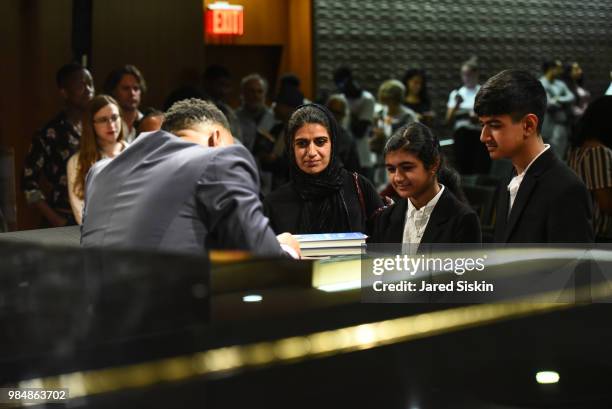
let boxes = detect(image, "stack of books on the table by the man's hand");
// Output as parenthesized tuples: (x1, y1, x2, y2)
(294, 233, 368, 257)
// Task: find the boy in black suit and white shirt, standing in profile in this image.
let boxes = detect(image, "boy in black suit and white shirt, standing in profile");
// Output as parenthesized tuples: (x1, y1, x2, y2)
(474, 70, 594, 243)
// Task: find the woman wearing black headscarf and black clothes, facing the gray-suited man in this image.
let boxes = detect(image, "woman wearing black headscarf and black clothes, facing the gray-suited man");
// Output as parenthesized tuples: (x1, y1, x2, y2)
(264, 104, 383, 234)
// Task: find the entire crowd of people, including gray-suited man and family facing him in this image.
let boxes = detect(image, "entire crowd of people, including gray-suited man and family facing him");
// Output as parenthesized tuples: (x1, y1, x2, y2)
(17, 58, 612, 255)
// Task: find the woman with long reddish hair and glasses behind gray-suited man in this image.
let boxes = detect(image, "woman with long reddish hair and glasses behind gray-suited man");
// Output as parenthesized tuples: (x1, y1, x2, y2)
(67, 95, 127, 224)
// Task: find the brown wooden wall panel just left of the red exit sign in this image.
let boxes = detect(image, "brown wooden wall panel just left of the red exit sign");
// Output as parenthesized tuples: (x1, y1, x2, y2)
(92, 0, 204, 108)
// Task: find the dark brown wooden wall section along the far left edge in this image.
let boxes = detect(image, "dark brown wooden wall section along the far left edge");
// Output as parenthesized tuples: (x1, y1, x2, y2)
(0, 0, 72, 229)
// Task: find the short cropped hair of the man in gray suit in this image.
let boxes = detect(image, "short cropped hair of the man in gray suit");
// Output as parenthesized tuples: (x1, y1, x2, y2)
(162, 98, 230, 133)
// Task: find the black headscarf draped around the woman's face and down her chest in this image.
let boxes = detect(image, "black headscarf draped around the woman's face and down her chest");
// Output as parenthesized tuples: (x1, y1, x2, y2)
(286, 104, 351, 233)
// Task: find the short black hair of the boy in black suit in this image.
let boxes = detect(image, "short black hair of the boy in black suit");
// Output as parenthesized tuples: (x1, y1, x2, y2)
(474, 70, 546, 132)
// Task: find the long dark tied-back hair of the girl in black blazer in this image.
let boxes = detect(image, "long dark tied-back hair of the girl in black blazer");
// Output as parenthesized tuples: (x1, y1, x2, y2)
(383, 122, 467, 203)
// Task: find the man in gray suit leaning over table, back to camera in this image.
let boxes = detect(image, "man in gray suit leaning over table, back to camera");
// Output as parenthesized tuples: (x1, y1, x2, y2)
(81, 99, 299, 257)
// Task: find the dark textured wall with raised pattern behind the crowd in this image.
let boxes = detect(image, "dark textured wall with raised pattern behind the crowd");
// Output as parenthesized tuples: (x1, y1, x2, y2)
(314, 0, 612, 121)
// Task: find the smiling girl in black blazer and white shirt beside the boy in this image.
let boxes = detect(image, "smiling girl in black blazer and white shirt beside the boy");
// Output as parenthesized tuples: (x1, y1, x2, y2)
(369, 123, 482, 245)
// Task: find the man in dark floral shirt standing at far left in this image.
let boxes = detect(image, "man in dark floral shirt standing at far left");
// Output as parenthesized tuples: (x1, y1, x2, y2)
(22, 63, 94, 227)
